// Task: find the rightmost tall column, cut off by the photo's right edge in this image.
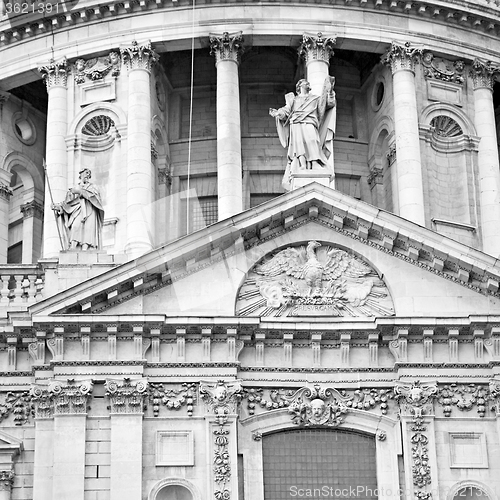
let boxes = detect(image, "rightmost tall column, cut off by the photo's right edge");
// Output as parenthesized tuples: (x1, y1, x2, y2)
(471, 59, 500, 257)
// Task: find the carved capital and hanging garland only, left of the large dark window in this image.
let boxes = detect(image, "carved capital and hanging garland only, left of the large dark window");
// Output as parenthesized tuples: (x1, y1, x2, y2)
(200, 380, 242, 500)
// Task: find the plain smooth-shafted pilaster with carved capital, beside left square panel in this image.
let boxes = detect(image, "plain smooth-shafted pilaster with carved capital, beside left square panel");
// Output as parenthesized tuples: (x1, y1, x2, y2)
(106, 378, 148, 500)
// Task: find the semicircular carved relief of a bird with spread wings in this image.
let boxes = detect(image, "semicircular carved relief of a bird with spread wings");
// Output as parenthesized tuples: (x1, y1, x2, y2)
(236, 241, 394, 316)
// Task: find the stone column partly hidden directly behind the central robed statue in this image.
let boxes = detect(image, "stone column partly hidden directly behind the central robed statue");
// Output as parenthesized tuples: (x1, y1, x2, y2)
(299, 33, 337, 188)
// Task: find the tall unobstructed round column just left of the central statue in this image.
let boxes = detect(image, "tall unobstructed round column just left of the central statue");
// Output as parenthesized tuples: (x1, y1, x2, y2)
(210, 32, 243, 220)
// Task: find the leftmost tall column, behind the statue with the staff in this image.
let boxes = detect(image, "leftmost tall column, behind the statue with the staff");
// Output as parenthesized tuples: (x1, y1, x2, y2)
(38, 59, 69, 258)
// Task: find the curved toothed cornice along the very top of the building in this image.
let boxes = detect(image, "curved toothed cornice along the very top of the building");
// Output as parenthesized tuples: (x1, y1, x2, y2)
(0, 0, 500, 46)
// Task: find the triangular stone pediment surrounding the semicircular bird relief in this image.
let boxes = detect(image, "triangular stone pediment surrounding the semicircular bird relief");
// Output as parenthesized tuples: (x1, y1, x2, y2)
(31, 183, 500, 318)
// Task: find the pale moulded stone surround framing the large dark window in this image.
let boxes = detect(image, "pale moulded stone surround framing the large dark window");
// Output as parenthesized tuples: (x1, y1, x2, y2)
(238, 409, 402, 500)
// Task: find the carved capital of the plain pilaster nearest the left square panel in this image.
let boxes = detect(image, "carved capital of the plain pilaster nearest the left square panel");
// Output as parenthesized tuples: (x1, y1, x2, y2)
(105, 378, 148, 414)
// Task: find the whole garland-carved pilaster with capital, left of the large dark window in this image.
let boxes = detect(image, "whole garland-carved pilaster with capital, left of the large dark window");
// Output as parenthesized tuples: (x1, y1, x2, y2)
(200, 380, 241, 500)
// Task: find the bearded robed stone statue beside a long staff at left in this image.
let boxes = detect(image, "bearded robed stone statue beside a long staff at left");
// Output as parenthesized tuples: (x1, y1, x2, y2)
(52, 168, 104, 250)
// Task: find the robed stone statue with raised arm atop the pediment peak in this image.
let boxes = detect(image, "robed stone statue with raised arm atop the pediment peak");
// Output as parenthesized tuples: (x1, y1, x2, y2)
(269, 76, 336, 190)
